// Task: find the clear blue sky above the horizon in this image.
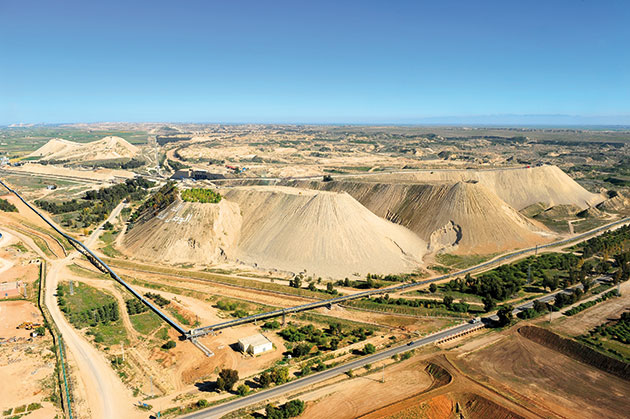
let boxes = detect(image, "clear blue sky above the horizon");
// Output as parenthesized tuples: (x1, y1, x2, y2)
(0, 0, 630, 124)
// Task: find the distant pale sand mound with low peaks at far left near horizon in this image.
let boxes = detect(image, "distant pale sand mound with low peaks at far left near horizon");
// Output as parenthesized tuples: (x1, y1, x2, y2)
(28, 137, 139, 162)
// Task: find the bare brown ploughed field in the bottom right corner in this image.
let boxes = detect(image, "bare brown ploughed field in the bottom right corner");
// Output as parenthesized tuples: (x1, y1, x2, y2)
(457, 332, 630, 418)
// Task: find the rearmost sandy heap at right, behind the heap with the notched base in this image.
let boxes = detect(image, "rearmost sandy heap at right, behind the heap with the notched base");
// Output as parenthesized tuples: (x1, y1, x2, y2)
(358, 165, 603, 210)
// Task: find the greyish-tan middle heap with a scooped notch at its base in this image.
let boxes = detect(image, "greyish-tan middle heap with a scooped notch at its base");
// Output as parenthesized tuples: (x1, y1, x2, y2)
(294, 181, 551, 254)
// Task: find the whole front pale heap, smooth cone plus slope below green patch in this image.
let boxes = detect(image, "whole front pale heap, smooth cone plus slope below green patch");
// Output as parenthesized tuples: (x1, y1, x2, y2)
(121, 187, 427, 278)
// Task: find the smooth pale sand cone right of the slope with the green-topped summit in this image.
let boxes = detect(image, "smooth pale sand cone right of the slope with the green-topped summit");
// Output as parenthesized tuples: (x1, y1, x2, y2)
(222, 186, 426, 277)
